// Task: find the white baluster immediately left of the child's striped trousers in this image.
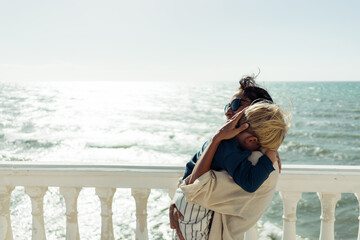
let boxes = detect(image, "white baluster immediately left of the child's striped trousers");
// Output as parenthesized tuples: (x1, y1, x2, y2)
(131, 188, 150, 240)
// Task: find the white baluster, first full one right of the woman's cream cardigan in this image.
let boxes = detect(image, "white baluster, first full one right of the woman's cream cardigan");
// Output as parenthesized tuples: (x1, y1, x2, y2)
(280, 192, 302, 240)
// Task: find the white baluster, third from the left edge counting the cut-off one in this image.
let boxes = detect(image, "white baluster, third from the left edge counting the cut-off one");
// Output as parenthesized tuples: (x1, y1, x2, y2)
(60, 187, 81, 240)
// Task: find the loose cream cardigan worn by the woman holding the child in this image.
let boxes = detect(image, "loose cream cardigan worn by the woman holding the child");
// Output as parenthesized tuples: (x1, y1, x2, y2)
(180, 154, 279, 240)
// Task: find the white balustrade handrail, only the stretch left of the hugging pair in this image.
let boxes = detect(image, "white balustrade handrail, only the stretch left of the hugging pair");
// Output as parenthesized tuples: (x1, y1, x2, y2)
(0, 162, 184, 189)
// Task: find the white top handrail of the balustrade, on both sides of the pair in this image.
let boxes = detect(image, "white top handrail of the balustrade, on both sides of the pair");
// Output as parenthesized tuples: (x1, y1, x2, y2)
(0, 162, 360, 193)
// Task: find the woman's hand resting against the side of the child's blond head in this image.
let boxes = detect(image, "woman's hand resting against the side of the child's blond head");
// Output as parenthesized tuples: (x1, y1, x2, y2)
(213, 108, 249, 142)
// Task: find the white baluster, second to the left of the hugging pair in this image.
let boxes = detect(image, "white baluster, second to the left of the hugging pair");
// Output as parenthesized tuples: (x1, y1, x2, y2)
(96, 188, 116, 240)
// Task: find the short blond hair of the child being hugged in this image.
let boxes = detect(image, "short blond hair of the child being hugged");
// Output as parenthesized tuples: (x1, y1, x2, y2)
(240, 102, 291, 150)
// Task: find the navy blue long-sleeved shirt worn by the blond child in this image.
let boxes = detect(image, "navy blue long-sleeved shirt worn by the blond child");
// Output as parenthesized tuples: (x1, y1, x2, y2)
(183, 138, 275, 192)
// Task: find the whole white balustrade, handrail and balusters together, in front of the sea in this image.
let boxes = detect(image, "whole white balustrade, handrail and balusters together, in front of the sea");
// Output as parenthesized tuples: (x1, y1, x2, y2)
(0, 162, 360, 240)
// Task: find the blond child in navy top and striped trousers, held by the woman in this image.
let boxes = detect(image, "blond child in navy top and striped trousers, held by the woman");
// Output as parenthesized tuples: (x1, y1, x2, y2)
(174, 102, 288, 239)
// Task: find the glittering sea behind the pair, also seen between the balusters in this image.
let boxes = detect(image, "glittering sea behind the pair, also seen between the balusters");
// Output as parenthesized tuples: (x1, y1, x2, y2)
(0, 81, 360, 240)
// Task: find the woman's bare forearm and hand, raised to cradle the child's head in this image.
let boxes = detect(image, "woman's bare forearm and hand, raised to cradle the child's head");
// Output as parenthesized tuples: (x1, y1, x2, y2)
(187, 108, 249, 184)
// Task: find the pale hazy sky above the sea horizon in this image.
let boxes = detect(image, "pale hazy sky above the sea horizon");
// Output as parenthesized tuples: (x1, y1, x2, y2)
(0, 0, 360, 81)
